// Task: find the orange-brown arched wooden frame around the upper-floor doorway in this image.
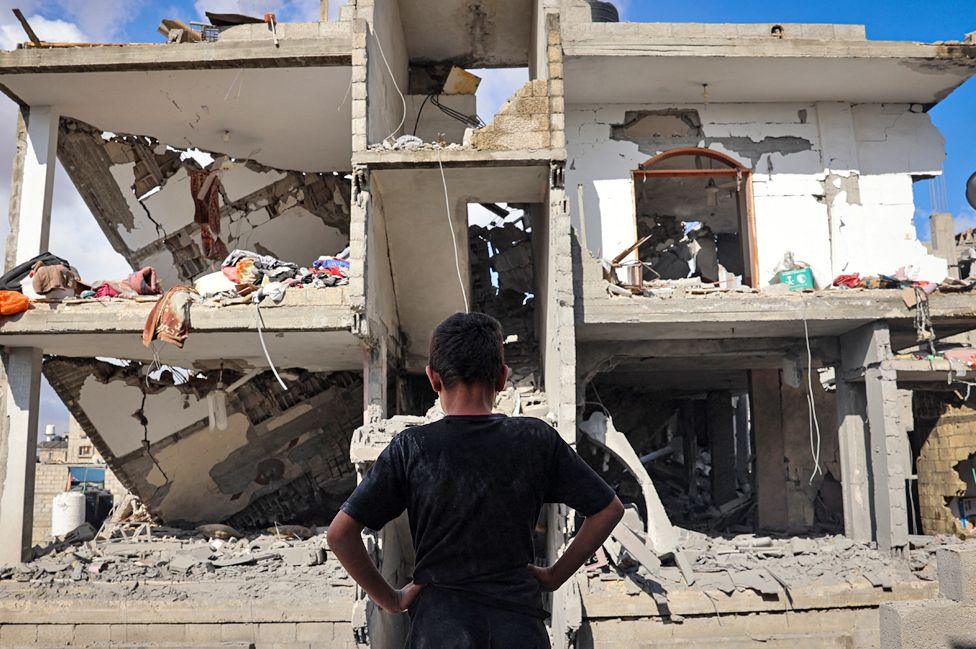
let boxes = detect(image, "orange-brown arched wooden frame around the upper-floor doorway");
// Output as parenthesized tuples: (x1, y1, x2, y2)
(633, 147, 759, 288)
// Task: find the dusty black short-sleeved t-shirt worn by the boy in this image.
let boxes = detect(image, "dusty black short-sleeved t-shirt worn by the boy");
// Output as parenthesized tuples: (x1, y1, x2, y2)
(342, 415, 614, 617)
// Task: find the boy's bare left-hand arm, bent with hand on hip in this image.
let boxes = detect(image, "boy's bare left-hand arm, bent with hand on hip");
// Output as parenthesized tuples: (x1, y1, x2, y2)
(328, 511, 424, 613)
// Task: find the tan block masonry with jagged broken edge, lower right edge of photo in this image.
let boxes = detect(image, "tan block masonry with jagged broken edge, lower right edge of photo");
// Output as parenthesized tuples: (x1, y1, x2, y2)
(916, 395, 976, 534)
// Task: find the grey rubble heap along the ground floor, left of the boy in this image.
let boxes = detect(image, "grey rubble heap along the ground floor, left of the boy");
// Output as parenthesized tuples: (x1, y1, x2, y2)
(0, 523, 353, 599)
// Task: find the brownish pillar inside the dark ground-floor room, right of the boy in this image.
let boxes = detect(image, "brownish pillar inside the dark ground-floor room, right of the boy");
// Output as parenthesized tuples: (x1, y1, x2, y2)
(749, 370, 789, 530)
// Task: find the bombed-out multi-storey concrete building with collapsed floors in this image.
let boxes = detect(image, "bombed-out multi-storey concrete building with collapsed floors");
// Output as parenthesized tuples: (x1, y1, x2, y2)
(0, 0, 976, 648)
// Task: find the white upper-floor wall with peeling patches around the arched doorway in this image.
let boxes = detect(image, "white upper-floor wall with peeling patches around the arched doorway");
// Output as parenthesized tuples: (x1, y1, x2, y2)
(566, 104, 944, 286)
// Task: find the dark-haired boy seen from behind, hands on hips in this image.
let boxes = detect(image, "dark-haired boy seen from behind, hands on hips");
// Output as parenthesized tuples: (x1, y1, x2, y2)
(329, 313, 623, 649)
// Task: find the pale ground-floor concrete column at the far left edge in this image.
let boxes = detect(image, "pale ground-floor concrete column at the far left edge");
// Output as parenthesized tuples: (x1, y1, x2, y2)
(0, 348, 41, 565)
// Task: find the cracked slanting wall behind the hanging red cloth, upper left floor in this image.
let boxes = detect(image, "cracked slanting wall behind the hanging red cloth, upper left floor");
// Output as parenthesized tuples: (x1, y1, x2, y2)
(58, 119, 351, 286)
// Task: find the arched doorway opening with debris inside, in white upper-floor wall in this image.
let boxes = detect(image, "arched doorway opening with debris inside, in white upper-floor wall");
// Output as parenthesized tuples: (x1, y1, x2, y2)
(634, 148, 758, 288)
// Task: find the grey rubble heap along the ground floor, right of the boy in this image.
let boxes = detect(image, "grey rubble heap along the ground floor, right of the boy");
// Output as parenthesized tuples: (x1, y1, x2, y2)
(586, 529, 963, 597)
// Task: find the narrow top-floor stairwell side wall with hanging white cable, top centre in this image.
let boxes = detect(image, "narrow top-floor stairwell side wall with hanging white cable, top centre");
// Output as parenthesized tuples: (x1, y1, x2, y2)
(360, 0, 410, 144)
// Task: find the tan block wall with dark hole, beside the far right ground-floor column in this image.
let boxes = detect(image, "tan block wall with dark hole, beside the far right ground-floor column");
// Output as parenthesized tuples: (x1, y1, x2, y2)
(912, 391, 976, 535)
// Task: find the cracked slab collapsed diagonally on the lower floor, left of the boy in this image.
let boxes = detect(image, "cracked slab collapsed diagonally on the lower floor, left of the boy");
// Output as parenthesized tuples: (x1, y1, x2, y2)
(44, 358, 362, 527)
